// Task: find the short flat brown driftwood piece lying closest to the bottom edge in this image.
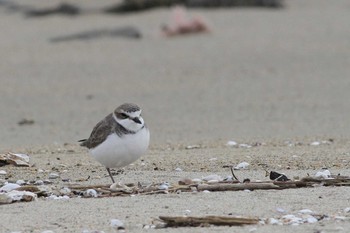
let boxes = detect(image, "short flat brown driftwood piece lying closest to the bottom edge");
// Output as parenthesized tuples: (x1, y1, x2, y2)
(159, 216, 259, 227)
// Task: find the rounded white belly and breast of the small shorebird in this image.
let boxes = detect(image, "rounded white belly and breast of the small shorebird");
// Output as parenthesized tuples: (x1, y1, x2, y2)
(90, 128, 150, 168)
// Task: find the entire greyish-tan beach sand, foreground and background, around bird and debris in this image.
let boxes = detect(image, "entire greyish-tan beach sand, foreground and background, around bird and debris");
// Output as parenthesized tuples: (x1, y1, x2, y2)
(0, 0, 350, 232)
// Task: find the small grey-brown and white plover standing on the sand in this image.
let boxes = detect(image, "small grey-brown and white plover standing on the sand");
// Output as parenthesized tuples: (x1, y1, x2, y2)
(79, 103, 150, 183)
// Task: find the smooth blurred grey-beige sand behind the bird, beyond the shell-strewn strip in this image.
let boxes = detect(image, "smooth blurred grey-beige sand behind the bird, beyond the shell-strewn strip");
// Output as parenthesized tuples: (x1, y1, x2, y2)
(0, 0, 350, 148)
